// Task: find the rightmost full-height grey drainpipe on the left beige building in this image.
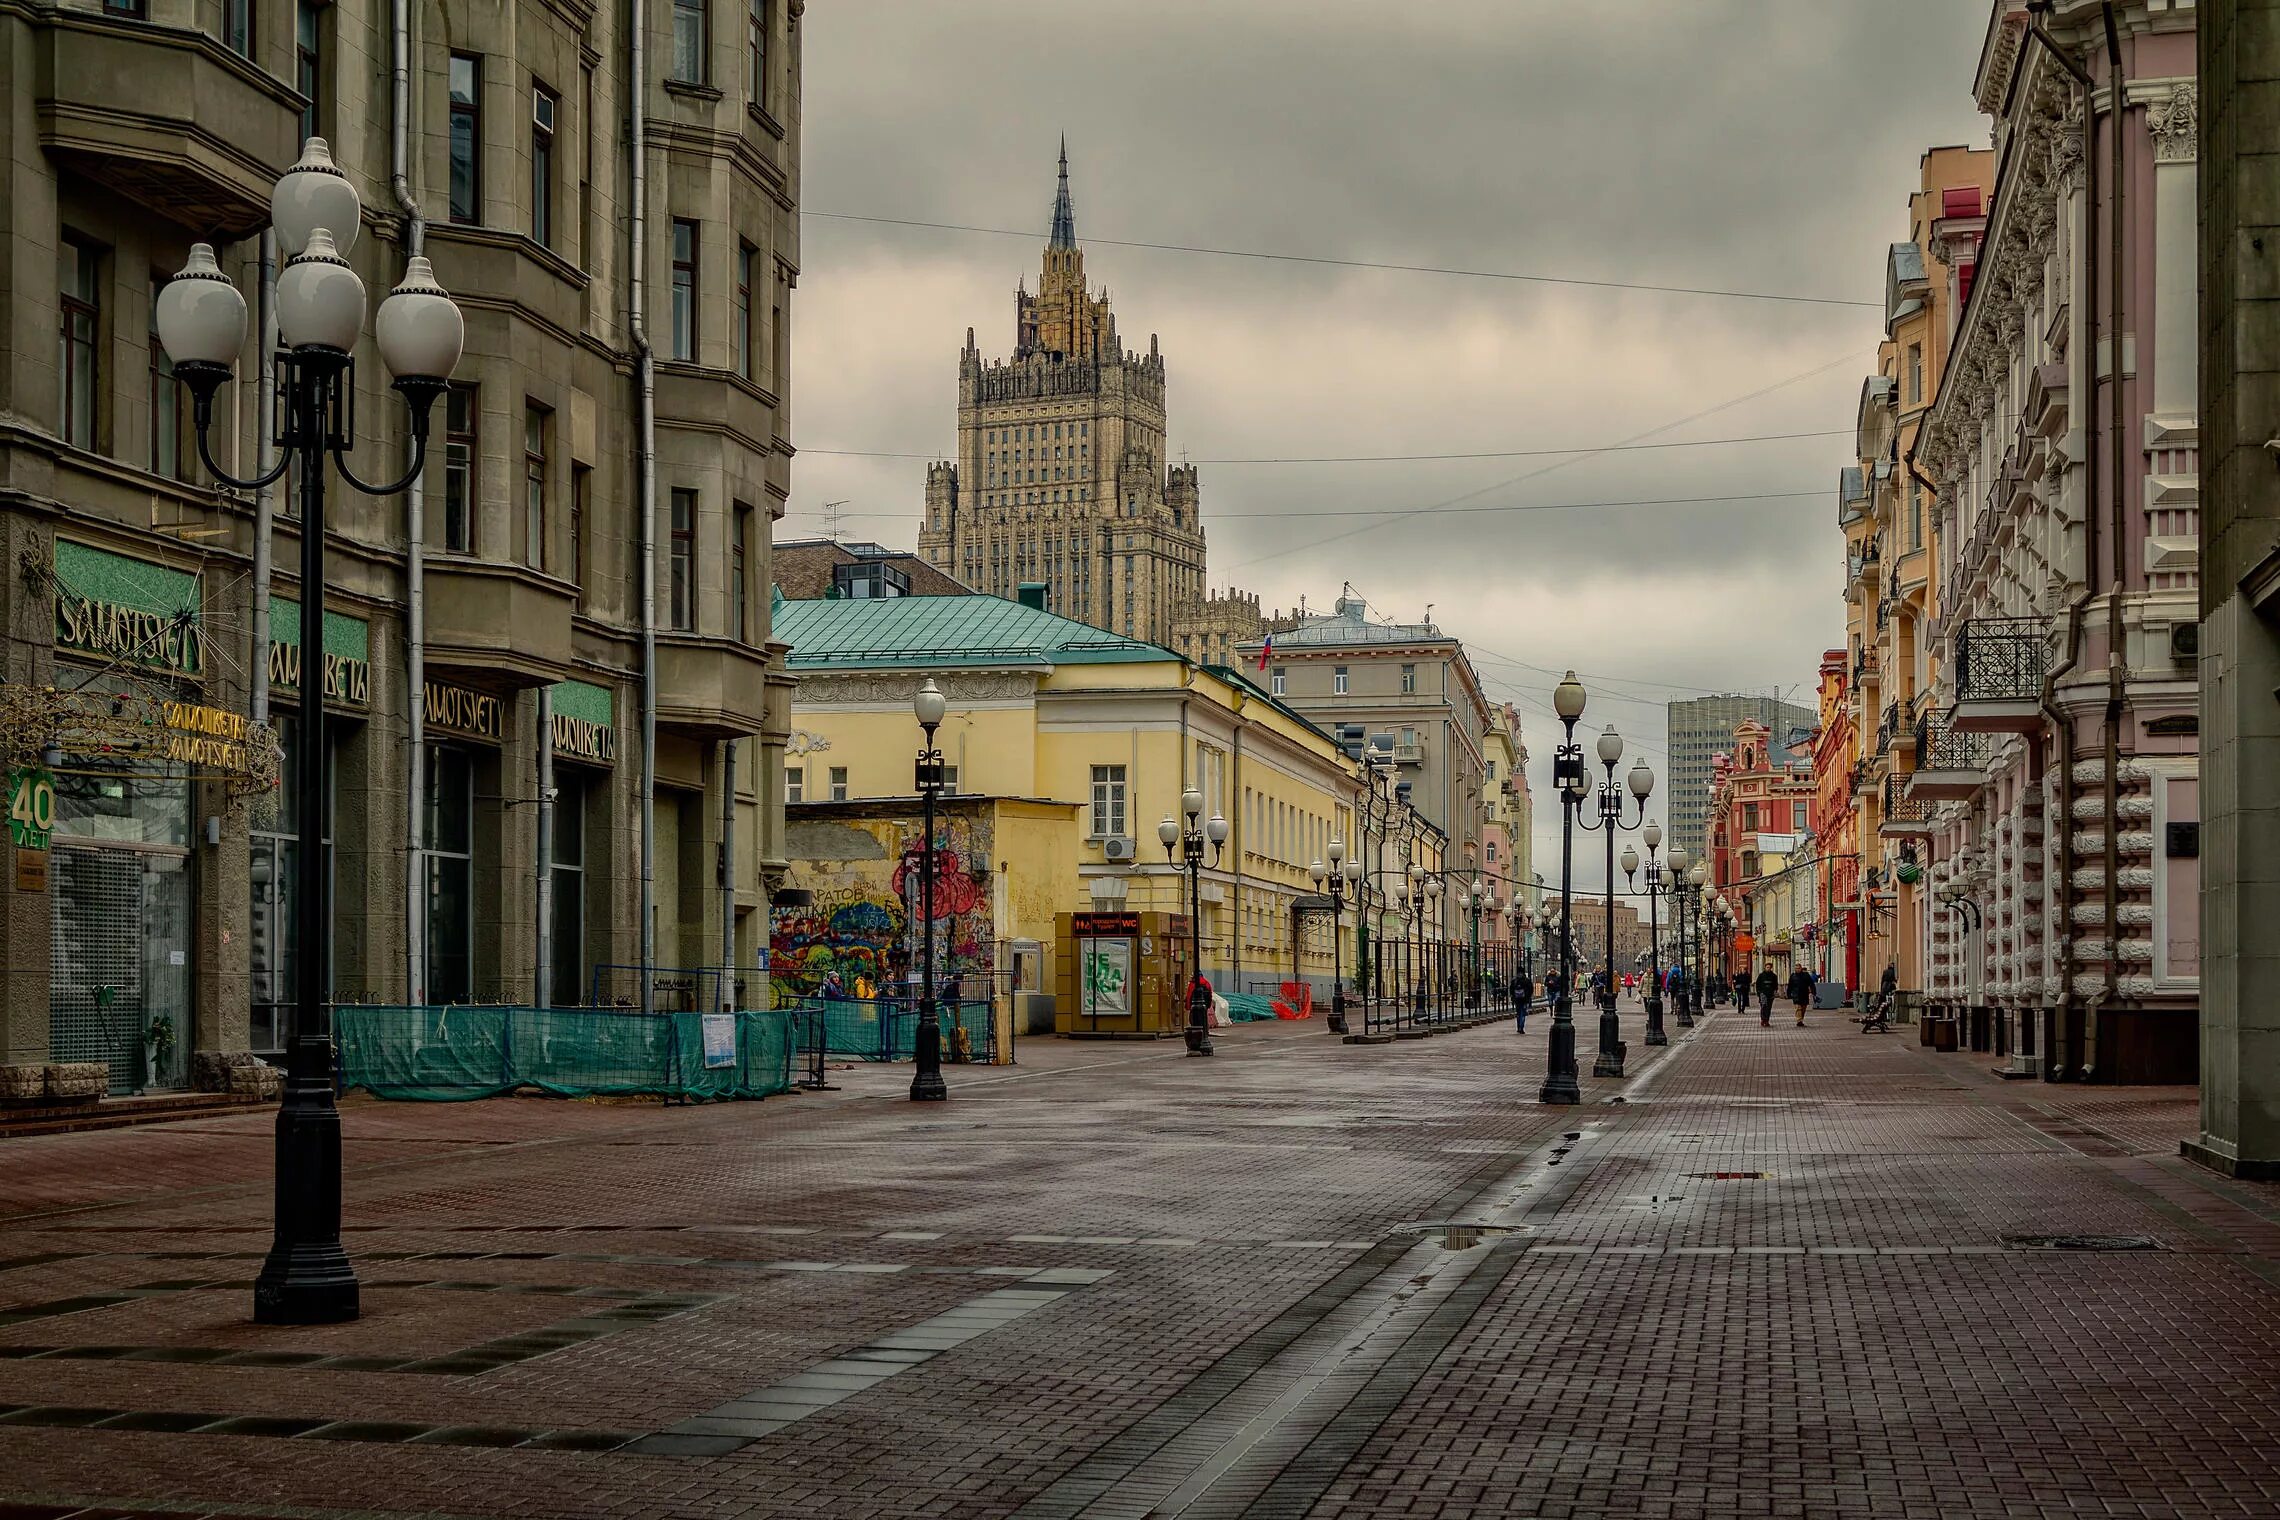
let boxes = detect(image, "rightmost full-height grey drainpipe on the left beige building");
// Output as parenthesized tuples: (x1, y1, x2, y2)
(629, 0, 657, 1012)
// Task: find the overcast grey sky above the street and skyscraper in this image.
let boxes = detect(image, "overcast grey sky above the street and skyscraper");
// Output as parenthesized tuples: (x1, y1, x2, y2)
(777, 0, 1988, 882)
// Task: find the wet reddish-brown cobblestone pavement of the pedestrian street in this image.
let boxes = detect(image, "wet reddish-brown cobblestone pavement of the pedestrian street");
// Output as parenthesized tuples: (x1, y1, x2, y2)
(0, 1010, 2280, 1520)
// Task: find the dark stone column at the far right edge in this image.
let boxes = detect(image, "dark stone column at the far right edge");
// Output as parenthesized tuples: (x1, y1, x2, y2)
(2184, 0, 2280, 1178)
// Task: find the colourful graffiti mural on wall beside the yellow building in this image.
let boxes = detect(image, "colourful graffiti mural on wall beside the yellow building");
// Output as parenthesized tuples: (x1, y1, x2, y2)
(768, 816, 996, 996)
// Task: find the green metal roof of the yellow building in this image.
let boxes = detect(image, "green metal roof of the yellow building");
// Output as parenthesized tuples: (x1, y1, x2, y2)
(775, 597, 1179, 670)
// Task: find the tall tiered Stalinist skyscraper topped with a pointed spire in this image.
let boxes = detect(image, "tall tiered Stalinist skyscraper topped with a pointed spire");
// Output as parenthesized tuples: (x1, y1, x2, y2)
(919, 141, 1222, 659)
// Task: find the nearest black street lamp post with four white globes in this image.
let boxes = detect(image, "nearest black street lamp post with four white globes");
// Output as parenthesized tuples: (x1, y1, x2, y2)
(157, 137, 465, 1324)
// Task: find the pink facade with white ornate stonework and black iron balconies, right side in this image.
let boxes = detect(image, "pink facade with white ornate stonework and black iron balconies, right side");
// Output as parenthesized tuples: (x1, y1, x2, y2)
(1902, 0, 2200, 1082)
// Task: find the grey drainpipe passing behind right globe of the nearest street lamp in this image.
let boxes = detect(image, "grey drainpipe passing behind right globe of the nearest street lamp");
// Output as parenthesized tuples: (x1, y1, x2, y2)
(387, 0, 426, 1005)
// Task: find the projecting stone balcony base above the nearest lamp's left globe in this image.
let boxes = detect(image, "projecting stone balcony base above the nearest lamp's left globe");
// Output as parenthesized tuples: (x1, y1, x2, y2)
(25, 11, 301, 242)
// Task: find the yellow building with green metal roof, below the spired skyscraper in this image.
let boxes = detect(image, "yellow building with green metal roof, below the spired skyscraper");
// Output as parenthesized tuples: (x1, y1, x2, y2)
(775, 597, 1357, 1000)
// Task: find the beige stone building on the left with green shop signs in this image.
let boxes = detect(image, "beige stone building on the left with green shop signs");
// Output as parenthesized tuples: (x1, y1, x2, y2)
(0, 0, 803, 1089)
